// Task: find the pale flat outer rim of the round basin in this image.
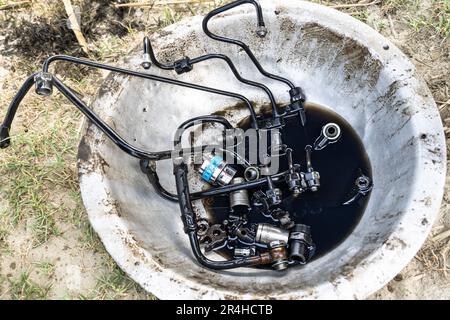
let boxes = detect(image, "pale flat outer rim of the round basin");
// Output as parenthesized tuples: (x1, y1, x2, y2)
(80, 0, 446, 299)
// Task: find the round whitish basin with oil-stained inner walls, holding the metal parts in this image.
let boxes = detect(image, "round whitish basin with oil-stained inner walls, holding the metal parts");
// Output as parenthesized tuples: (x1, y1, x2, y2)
(78, 0, 446, 299)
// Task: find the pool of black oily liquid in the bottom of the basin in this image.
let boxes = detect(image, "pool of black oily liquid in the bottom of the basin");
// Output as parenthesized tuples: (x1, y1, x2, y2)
(203, 103, 372, 259)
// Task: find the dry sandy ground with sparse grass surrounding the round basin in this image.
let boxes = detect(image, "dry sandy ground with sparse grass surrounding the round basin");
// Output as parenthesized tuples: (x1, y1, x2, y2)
(0, 0, 450, 299)
